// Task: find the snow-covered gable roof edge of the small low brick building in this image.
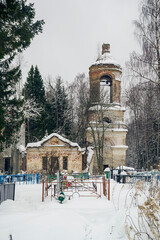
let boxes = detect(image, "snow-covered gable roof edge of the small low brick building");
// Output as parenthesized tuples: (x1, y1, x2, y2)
(26, 133, 82, 151)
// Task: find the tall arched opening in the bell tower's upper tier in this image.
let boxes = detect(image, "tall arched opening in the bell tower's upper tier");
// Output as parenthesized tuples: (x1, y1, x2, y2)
(100, 75, 112, 103)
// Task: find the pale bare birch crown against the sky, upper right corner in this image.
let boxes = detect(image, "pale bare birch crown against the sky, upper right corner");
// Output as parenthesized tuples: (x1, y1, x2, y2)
(127, 0, 160, 89)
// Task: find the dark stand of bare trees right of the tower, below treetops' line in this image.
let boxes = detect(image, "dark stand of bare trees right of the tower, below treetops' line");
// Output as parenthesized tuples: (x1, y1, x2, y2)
(126, 82, 160, 169)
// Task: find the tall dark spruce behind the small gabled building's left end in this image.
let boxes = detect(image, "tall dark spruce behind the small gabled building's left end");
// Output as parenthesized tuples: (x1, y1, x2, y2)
(24, 66, 46, 143)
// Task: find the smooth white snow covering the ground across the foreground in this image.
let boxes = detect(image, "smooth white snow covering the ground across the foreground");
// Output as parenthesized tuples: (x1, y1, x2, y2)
(0, 181, 138, 240)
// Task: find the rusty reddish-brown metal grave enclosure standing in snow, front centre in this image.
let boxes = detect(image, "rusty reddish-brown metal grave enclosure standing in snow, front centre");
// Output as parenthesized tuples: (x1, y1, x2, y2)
(42, 177, 110, 201)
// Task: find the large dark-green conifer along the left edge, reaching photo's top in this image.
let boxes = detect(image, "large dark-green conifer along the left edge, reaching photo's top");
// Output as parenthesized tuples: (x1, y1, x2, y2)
(0, 0, 44, 151)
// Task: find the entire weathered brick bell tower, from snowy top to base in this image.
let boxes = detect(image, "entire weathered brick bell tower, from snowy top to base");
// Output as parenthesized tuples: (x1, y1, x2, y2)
(86, 44, 128, 172)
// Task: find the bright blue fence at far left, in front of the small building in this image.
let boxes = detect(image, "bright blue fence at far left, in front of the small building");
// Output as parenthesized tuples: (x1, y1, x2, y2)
(0, 173, 40, 184)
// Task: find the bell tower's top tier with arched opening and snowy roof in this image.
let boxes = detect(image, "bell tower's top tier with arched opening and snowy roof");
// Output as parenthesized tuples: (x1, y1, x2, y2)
(89, 44, 122, 104)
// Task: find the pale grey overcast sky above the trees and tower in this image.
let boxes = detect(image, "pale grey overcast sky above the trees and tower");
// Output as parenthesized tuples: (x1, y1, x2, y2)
(23, 0, 140, 85)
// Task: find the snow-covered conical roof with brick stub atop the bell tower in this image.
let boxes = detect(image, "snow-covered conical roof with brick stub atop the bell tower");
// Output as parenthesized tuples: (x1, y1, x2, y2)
(92, 43, 121, 68)
